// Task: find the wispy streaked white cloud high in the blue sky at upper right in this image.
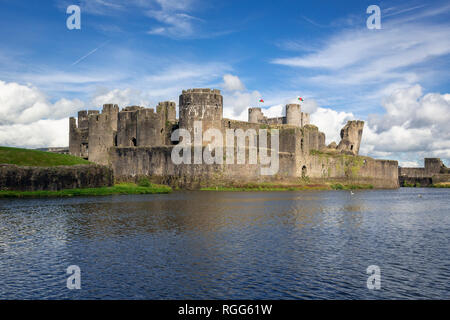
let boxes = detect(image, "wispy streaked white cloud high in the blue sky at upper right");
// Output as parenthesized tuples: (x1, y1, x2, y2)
(272, 5, 450, 112)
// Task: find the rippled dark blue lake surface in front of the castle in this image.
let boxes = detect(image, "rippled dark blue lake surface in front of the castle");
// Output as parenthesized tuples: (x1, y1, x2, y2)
(0, 188, 450, 299)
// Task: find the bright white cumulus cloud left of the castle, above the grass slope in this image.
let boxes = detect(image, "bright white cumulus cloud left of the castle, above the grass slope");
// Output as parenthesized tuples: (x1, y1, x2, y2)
(0, 81, 84, 147)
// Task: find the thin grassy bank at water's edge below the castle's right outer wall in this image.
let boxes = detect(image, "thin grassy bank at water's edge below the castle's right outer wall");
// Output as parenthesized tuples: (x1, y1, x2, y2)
(200, 183, 373, 191)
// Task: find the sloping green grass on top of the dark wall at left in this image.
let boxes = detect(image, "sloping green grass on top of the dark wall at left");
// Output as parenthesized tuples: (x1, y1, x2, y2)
(0, 147, 91, 167)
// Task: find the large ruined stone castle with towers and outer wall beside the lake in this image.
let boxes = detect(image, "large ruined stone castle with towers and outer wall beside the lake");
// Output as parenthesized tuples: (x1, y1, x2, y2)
(69, 89, 398, 188)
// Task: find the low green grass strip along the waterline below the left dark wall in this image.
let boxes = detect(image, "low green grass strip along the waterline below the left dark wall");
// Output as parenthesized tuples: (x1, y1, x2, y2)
(0, 183, 172, 198)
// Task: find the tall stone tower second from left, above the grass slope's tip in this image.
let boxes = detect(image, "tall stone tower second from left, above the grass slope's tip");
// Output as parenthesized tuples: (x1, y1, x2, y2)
(89, 104, 119, 165)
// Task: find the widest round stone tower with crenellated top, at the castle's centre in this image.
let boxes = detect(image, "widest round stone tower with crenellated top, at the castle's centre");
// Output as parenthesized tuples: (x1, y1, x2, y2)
(179, 89, 223, 139)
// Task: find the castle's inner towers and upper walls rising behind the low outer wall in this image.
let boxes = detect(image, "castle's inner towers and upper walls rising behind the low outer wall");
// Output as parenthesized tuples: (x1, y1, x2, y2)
(69, 88, 364, 172)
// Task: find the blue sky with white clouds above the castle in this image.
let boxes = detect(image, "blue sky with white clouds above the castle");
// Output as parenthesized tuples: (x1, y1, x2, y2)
(0, 0, 450, 165)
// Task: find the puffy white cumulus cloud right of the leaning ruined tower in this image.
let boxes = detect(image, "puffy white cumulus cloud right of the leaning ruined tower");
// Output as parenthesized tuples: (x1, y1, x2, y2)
(361, 85, 450, 162)
